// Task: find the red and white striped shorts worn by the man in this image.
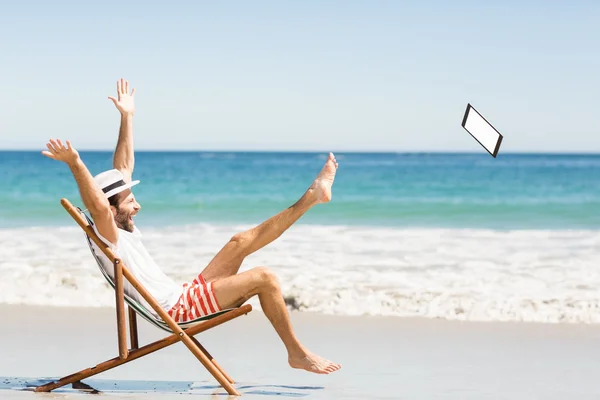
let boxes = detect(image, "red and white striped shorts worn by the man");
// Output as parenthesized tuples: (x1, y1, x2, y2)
(168, 274, 221, 323)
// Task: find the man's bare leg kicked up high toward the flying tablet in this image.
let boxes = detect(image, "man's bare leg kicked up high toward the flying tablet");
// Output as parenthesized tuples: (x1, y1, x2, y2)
(202, 153, 338, 282)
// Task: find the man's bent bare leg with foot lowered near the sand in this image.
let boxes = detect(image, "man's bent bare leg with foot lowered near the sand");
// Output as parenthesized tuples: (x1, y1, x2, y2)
(213, 268, 341, 374)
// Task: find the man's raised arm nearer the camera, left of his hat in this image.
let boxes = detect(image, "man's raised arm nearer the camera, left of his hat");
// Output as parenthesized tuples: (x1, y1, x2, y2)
(42, 139, 119, 244)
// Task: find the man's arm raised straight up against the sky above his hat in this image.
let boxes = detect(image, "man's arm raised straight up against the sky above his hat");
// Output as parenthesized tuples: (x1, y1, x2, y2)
(108, 78, 135, 182)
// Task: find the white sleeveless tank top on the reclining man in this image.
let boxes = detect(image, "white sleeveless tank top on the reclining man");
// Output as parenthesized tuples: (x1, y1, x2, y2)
(92, 225, 183, 319)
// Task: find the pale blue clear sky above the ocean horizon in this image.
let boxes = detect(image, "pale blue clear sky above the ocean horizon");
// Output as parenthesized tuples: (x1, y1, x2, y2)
(0, 1, 600, 152)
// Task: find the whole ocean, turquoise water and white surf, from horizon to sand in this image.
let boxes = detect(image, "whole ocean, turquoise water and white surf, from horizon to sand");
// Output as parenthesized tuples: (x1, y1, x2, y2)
(0, 151, 600, 323)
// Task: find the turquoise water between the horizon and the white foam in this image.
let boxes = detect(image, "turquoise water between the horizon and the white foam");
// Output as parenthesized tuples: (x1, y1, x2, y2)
(0, 152, 600, 229)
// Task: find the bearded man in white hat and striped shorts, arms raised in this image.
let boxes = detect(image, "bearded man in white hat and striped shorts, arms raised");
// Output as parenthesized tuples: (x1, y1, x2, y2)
(42, 79, 341, 374)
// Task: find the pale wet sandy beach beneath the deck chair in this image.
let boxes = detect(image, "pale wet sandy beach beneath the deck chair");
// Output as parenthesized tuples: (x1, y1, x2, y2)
(0, 306, 600, 400)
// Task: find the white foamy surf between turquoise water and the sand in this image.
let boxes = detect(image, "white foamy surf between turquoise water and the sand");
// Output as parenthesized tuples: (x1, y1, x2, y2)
(0, 225, 600, 323)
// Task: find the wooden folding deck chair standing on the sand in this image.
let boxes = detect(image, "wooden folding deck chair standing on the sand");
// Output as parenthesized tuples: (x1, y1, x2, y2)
(34, 199, 252, 396)
